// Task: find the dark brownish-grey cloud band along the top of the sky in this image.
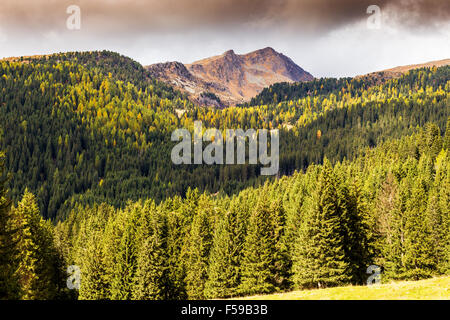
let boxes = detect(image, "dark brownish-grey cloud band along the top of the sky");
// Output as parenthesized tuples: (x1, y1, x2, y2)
(0, 0, 450, 33)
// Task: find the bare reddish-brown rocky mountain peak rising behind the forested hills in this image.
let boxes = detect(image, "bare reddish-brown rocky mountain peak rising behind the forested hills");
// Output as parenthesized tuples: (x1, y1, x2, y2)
(147, 48, 314, 106)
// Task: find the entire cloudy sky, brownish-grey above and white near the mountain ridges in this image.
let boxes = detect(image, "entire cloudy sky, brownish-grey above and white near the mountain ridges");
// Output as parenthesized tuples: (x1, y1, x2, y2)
(0, 0, 450, 77)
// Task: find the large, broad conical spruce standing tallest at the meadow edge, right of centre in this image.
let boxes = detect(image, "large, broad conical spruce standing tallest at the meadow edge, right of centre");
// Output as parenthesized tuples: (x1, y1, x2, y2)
(293, 159, 351, 288)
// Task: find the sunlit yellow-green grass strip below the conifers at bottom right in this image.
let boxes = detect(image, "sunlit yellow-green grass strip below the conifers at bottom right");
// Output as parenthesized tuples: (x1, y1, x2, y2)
(237, 276, 450, 300)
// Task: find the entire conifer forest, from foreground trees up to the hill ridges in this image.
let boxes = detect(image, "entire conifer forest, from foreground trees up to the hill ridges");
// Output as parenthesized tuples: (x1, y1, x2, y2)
(0, 52, 450, 299)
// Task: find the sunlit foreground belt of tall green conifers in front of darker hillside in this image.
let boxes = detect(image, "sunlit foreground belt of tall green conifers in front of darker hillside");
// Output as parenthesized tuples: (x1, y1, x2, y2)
(0, 119, 450, 299)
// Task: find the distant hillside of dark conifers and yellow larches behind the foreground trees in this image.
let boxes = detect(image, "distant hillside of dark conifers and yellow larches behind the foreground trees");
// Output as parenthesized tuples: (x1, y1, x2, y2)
(0, 52, 450, 219)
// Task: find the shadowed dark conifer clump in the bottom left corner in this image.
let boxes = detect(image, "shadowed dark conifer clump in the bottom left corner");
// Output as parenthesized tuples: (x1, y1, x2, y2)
(0, 154, 68, 300)
